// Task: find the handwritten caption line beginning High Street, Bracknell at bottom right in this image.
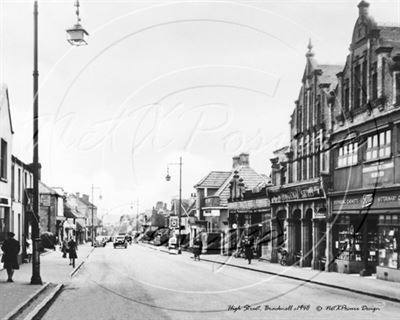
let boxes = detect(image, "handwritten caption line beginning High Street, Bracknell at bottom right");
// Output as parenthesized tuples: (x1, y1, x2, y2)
(228, 304, 381, 313)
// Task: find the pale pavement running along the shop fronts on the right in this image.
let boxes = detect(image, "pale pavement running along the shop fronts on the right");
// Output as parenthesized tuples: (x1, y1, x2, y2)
(142, 244, 400, 302)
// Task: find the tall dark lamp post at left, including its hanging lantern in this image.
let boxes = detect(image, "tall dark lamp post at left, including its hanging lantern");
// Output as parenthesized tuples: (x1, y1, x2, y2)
(31, 0, 88, 284)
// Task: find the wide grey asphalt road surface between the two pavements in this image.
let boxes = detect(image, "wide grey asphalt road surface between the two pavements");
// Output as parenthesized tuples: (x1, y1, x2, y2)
(43, 244, 400, 320)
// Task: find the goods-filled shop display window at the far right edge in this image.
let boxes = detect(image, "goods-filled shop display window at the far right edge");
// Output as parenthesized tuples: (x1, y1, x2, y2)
(379, 215, 400, 269)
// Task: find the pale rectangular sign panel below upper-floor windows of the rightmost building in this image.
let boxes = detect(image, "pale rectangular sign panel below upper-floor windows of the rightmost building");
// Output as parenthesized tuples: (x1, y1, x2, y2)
(362, 160, 394, 187)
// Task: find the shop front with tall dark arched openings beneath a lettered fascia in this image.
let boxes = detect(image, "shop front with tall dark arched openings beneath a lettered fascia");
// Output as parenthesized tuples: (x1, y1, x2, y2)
(268, 181, 327, 270)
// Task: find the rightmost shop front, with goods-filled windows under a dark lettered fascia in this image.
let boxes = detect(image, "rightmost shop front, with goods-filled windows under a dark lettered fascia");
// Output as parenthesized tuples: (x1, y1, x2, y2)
(332, 189, 400, 281)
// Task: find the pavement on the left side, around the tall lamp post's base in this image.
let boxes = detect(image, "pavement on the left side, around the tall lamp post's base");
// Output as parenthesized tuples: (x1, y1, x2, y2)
(0, 243, 93, 319)
